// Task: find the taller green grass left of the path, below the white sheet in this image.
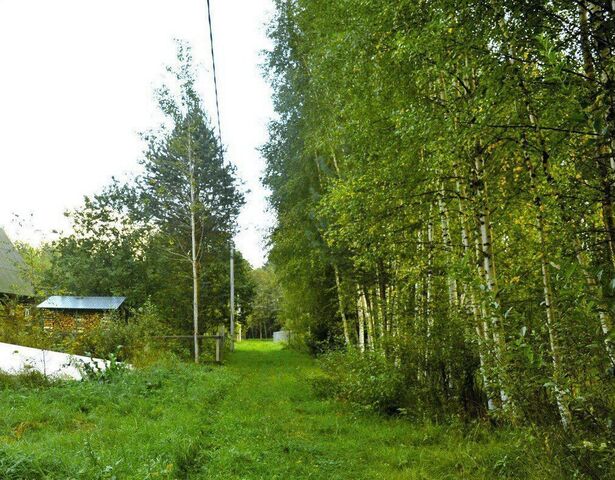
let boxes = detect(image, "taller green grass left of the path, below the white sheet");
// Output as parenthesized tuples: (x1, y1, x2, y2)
(0, 364, 237, 480)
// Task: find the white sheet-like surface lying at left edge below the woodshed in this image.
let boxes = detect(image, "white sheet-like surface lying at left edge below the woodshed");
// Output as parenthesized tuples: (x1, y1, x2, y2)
(0, 343, 107, 380)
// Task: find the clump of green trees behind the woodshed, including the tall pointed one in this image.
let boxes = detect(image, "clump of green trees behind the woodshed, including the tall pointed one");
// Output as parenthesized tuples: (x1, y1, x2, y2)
(30, 43, 253, 334)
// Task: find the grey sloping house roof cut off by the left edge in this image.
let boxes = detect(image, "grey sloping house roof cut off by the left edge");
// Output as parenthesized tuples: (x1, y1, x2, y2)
(0, 228, 34, 297)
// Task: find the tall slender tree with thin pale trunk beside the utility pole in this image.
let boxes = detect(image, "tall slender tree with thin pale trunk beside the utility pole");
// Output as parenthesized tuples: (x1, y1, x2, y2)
(139, 44, 243, 362)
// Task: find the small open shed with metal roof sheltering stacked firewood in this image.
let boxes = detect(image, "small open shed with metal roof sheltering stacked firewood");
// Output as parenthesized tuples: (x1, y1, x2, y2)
(38, 296, 126, 334)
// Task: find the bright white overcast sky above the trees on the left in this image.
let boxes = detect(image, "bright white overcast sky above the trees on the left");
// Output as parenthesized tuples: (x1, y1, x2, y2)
(0, 0, 273, 266)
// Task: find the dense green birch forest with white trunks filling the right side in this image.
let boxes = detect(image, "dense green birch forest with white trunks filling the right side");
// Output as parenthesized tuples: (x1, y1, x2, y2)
(263, 0, 615, 473)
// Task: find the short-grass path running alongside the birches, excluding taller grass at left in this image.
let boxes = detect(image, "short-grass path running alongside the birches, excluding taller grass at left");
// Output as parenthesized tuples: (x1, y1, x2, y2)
(187, 342, 532, 480)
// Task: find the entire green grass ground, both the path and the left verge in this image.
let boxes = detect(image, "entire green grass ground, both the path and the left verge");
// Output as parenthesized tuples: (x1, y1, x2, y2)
(0, 342, 562, 480)
